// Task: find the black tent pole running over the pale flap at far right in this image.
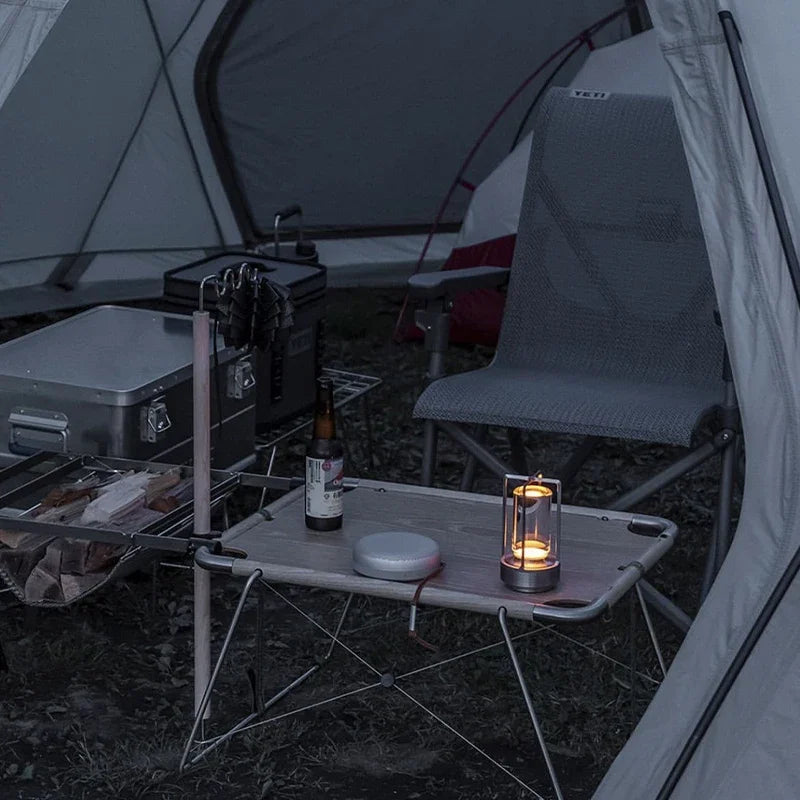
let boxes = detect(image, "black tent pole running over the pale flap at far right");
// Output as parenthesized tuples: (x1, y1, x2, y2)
(656, 11, 800, 800)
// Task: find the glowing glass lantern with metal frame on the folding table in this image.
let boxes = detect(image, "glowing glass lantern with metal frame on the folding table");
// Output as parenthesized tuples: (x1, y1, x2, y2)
(500, 475, 561, 592)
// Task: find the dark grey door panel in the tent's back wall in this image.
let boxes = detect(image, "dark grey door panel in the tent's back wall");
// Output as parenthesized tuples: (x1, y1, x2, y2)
(216, 0, 624, 236)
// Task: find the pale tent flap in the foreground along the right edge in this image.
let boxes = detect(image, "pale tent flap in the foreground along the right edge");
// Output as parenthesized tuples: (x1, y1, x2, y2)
(595, 0, 800, 800)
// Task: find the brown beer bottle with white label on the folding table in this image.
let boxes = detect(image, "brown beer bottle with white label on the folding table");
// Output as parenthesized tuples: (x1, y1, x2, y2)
(306, 378, 344, 531)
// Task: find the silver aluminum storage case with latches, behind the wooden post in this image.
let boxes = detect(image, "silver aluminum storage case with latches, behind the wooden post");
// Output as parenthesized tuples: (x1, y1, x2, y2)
(0, 306, 255, 468)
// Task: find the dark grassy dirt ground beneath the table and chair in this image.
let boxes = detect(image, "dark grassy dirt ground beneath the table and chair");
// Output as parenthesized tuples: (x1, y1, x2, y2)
(0, 290, 732, 800)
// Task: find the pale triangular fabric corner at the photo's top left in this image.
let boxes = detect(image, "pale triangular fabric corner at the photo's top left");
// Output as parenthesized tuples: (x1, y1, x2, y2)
(0, 0, 67, 108)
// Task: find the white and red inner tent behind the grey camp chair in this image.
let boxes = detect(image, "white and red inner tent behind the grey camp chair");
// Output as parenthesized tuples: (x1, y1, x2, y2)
(443, 30, 669, 344)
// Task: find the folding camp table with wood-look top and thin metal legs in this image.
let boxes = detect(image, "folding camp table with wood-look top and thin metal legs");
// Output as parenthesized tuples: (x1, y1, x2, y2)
(181, 480, 677, 798)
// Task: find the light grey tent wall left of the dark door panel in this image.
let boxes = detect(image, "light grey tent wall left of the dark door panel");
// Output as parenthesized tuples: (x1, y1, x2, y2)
(0, 0, 242, 316)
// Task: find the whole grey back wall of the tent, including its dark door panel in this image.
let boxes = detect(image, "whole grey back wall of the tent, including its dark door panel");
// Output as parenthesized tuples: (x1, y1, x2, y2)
(0, 0, 640, 316)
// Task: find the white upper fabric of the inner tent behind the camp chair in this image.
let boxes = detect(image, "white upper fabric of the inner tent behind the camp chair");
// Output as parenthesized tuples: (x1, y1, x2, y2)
(455, 30, 669, 253)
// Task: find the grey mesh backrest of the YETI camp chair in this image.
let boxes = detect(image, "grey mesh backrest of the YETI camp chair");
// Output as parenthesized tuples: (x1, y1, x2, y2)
(495, 89, 723, 386)
